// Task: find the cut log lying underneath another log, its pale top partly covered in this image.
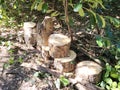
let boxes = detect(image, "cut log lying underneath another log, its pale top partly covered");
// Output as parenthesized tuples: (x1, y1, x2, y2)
(54, 50, 76, 72)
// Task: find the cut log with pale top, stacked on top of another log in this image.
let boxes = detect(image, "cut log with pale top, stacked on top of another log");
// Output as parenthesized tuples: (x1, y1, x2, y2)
(48, 34, 71, 58)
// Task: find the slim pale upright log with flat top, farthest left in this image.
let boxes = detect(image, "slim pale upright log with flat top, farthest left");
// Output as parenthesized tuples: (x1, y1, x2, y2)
(23, 22, 37, 48)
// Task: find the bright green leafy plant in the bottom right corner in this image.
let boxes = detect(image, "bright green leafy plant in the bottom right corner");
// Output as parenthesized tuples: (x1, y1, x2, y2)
(100, 61, 120, 90)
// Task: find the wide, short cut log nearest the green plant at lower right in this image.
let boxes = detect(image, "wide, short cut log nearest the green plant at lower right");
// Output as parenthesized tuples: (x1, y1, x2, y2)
(75, 61, 102, 83)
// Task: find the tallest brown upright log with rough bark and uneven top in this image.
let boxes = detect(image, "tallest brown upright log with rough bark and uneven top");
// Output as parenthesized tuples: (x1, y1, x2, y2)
(37, 16, 53, 47)
